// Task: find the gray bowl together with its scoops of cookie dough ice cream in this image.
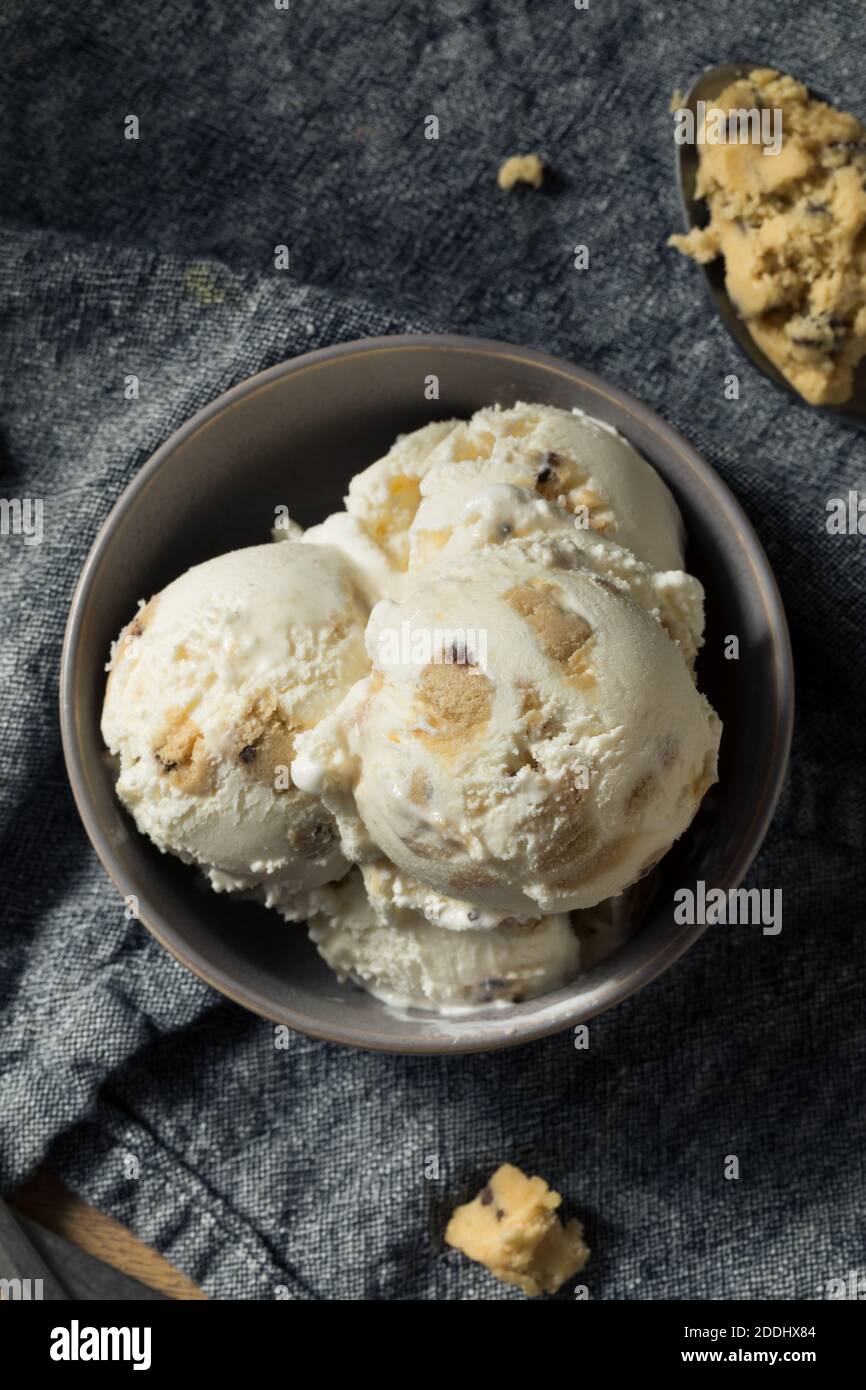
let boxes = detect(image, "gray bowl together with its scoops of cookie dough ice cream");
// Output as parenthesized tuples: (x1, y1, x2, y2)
(61, 336, 792, 1052)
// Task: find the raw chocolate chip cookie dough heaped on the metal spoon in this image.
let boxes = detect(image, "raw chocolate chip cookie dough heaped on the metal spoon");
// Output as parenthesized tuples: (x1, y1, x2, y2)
(669, 68, 866, 406)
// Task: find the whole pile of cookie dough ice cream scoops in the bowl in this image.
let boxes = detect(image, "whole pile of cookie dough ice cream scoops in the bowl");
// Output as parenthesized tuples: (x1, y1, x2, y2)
(103, 403, 720, 1012)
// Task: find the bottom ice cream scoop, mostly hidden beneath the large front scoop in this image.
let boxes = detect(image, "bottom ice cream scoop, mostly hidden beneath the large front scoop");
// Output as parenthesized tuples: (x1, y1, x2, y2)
(310, 870, 580, 1013)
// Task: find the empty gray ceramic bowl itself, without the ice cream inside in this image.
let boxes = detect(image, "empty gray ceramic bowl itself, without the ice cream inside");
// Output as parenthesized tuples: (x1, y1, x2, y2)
(61, 336, 794, 1052)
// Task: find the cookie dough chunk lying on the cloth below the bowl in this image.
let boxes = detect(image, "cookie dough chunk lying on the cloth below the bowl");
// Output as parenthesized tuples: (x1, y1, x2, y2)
(445, 1163, 589, 1298)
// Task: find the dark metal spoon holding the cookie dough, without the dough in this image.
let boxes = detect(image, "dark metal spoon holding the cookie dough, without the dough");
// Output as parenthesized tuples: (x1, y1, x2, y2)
(677, 63, 866, 431)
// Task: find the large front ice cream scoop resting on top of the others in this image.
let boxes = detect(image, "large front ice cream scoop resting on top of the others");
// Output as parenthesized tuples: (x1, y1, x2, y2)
(292, 539, 720, 916)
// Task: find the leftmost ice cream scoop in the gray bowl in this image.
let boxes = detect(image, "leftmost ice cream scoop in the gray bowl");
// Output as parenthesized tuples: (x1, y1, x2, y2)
(101, 541, 370, 916)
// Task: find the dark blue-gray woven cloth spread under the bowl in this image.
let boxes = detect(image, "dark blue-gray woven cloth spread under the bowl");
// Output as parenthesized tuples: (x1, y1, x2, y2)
(0, 0, 866, 1301)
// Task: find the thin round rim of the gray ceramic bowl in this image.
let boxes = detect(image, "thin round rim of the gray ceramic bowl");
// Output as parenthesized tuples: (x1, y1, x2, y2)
(58, 334, 794, 1055)
